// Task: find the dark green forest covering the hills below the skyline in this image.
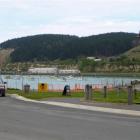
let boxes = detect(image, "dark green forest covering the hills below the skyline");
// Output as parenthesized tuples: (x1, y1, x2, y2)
(0, 32, 136, 62)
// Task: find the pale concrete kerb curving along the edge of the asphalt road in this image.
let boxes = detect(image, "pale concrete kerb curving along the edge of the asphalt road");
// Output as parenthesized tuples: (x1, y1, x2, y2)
(10, 94, 140, 117)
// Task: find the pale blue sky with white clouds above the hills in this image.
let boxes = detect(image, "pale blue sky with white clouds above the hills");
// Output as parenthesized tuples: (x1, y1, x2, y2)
(0, 0, 140, 42)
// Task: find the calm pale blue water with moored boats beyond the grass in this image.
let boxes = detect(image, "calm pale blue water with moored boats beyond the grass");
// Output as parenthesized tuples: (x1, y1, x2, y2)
(2, 75, 140, 90)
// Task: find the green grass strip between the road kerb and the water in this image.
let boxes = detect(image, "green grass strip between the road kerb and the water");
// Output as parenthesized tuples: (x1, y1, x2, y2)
(7, 90, 140, 104)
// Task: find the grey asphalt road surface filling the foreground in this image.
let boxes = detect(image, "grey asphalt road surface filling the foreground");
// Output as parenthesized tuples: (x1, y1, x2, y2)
(0, 97, 140, 140)
